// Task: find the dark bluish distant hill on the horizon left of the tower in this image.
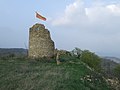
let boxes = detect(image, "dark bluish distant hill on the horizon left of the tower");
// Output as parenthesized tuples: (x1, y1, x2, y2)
(0, 48, 27, 57)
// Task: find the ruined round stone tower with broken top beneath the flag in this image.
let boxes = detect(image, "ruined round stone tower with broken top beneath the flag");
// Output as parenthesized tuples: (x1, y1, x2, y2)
(28, 23, 55, 58)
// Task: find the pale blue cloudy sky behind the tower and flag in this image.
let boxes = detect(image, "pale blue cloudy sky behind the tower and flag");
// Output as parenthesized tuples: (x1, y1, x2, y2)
(0, 0, 120, 58)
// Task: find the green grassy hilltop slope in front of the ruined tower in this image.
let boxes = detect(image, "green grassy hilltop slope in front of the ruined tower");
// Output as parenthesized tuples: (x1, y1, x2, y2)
(0, 56, 110, 90)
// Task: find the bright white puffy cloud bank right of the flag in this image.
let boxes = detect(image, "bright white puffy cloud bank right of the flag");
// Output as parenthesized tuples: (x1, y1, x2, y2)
(52, 0, 120, 26)
